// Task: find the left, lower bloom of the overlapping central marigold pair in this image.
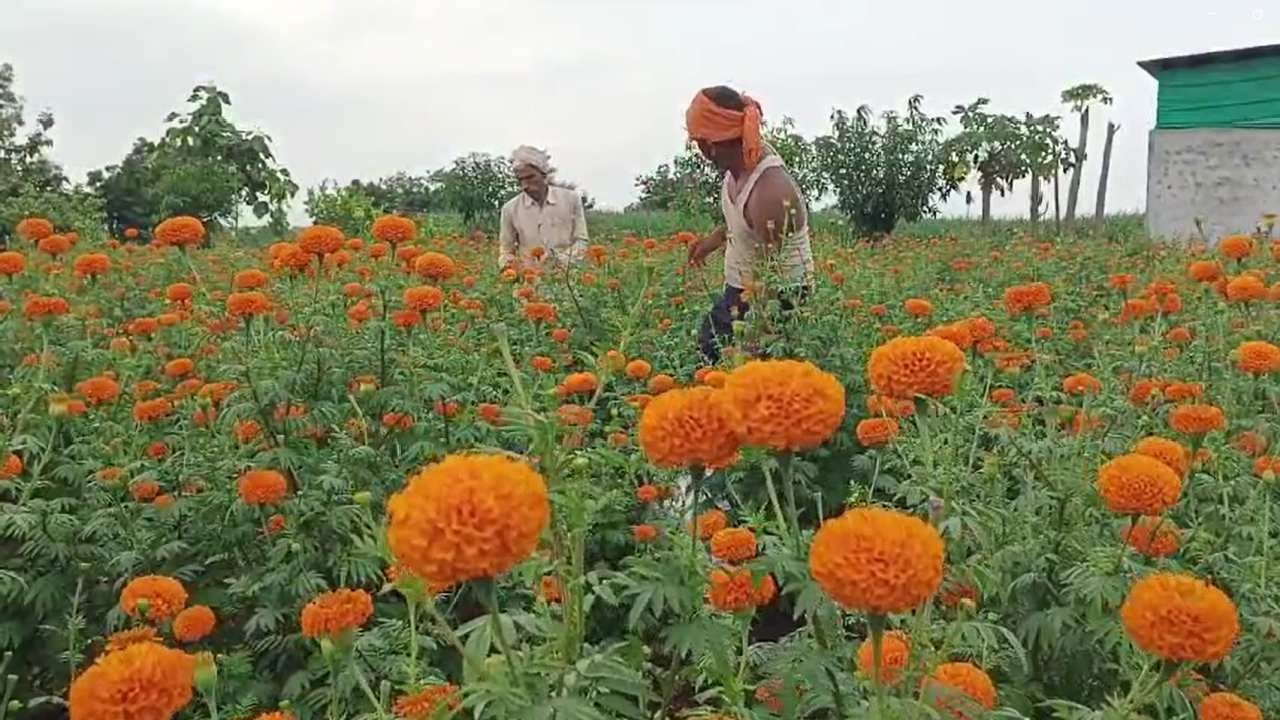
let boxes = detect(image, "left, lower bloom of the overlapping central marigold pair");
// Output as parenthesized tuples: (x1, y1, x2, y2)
(639, 387, 740, 469)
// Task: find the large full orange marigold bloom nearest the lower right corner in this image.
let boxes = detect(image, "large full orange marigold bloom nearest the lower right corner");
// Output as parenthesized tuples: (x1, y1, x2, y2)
(1120, 573, 1240, 662)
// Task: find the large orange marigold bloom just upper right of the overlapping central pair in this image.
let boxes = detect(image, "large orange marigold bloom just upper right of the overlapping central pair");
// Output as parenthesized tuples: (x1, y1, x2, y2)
(867, 336, 965, 398)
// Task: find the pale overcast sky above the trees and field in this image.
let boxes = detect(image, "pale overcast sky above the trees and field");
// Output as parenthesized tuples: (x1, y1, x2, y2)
(0, 0, 1280, 220)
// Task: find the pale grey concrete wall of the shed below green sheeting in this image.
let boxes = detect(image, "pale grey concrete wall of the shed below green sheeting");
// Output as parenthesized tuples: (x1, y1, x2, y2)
(1147, 128, 1280, 242)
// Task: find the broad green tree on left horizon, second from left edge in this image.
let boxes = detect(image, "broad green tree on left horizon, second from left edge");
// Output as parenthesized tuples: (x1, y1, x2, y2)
(88, 85, 298, 232)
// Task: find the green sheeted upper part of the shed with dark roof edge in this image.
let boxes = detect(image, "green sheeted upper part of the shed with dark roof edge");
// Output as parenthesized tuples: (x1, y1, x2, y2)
(1138, 45, 1280, 128)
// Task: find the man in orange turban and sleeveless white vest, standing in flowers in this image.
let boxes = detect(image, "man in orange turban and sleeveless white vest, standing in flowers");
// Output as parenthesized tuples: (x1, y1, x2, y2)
(685, 86, 813, 364)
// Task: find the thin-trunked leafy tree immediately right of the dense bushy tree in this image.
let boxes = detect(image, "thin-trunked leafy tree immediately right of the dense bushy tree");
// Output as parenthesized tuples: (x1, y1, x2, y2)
(947, 97, 1030, 223)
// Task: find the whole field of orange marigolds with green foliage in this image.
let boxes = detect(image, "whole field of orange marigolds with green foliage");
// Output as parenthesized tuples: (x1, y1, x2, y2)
(0, 217, 1280, 720)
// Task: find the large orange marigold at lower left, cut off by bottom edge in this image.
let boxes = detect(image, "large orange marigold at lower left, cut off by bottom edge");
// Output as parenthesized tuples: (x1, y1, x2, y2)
(68, 642, 196, 720)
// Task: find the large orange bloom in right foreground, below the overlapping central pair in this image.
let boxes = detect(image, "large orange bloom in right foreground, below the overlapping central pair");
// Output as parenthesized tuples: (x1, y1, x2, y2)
(809, 507, 943, 615)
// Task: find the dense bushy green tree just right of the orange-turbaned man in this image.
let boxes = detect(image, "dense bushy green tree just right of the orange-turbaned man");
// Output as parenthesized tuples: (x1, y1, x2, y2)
(813, 95, 963, 233)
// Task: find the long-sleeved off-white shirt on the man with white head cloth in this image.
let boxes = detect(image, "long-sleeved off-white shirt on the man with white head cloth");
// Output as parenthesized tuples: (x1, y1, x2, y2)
(498, 184, 588, 268)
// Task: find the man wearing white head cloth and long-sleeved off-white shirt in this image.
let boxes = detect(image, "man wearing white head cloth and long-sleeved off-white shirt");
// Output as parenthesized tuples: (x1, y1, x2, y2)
(498, 145, 588, 268)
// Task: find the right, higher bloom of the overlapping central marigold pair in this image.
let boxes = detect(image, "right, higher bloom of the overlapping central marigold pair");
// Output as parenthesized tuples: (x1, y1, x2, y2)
(723, 360, 845, 452)
